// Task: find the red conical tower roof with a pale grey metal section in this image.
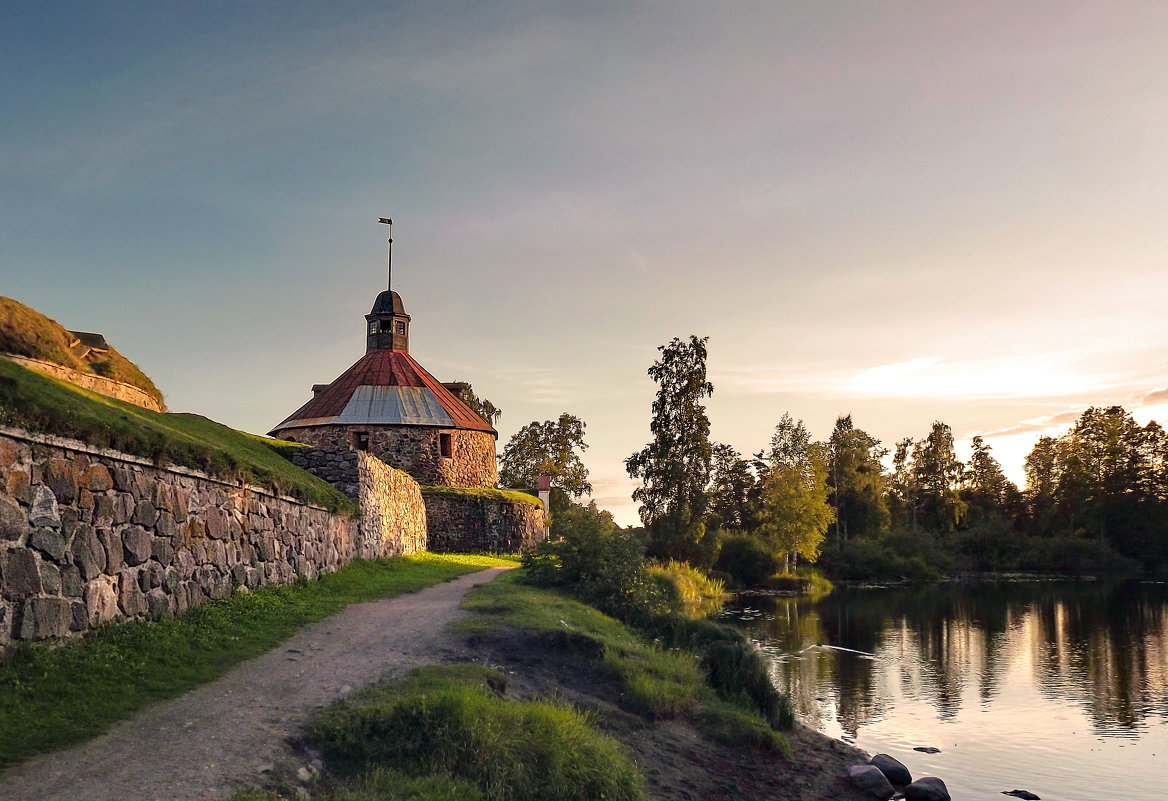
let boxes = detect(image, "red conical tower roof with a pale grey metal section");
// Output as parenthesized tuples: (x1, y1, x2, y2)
(271, 350, 499, 437)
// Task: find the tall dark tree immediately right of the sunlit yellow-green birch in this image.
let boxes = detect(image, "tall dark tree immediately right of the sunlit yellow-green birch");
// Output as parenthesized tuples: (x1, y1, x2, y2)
(827, 415, 889, 546)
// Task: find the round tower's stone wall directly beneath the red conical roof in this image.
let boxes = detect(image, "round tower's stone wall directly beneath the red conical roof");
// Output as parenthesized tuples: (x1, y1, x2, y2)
(281, 425, 499, 487)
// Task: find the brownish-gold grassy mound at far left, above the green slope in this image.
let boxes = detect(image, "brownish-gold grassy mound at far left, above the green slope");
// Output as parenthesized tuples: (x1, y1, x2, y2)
(0, 297, 162, 403)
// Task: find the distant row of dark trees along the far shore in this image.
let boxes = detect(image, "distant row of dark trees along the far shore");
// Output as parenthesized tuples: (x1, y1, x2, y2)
(709, 406, 1168, 580)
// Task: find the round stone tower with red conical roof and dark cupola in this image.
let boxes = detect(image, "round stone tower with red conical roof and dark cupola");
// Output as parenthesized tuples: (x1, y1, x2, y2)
(271, 291, 499, 487)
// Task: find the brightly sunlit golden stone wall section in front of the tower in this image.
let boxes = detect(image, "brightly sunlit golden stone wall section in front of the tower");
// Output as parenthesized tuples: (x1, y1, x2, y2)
(355, 453, 427, 556)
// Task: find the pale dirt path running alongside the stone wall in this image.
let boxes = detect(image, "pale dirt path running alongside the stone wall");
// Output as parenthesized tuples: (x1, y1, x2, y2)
(0, 567, 506, 801)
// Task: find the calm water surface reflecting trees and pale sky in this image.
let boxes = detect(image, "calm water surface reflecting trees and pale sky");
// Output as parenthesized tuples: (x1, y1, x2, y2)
(725, 581, 1168, 801)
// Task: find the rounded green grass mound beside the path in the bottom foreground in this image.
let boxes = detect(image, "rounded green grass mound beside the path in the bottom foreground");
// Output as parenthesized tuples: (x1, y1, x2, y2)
(313, 666, 644, 801)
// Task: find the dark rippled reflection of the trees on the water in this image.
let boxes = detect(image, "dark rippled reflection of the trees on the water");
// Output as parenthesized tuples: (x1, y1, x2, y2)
(742, 581, 1168, 734)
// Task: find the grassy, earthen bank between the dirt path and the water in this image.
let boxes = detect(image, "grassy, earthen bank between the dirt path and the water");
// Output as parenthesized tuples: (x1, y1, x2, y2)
(237, 574, 865, 801)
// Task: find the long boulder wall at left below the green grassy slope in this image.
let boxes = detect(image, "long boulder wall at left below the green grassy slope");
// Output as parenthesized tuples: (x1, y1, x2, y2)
(0, 429, 364, 650)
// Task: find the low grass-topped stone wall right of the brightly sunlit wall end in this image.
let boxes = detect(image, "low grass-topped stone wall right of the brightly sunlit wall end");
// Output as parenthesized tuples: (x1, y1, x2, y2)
(422, 490, 548, 553)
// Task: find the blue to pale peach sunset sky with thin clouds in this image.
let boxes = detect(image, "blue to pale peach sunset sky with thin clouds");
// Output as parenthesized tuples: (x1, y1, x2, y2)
(0, 0, 1168, 523)
